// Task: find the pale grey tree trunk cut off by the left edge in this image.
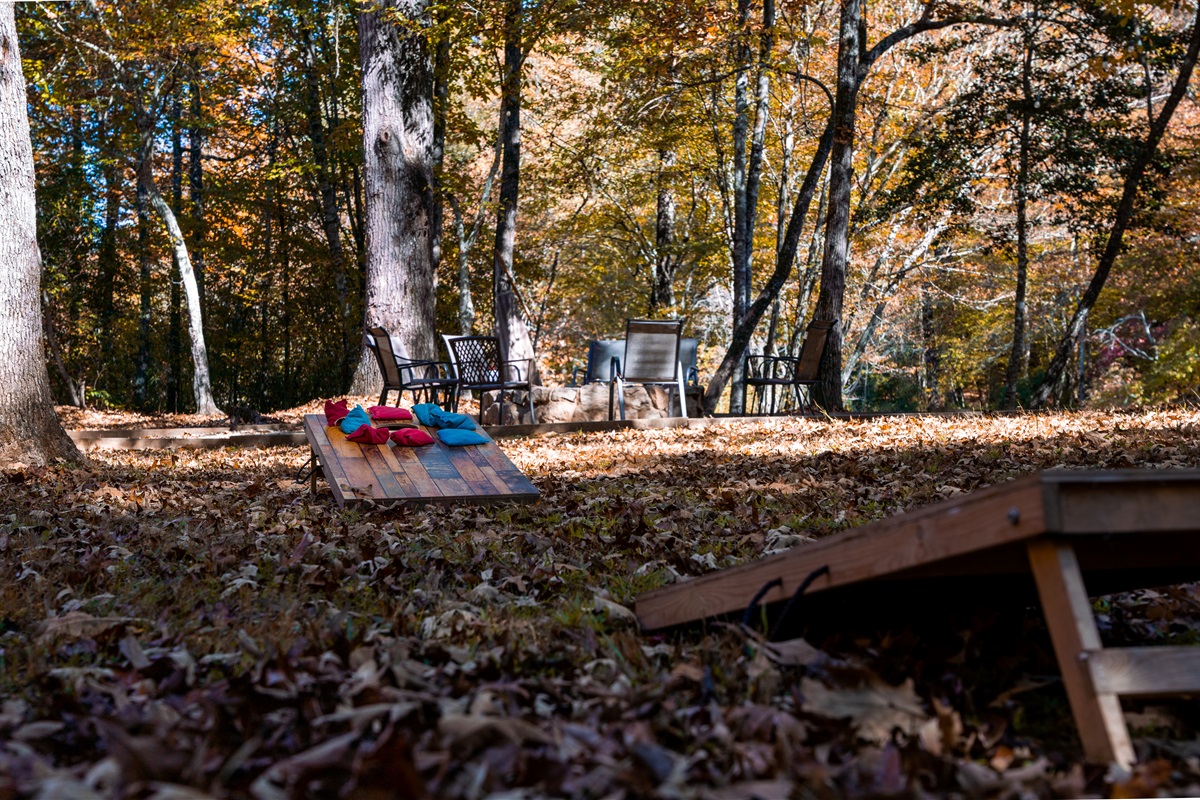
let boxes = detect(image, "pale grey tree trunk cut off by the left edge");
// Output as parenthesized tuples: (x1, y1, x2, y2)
(0, 2, 82, 467)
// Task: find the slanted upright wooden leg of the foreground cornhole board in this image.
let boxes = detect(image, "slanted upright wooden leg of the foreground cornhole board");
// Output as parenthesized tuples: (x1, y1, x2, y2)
(1027, 539, 1135, 768)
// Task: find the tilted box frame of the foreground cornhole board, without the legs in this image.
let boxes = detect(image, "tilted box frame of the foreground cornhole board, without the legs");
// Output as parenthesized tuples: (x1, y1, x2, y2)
(636, 470, 1200, 630)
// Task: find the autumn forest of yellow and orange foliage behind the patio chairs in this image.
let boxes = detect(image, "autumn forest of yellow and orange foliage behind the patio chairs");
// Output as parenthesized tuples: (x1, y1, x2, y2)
(18, 0, 1200, 422)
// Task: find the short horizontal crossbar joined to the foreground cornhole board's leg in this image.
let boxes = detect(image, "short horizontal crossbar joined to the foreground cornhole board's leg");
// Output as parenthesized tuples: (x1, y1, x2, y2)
(1084, 646, 1200, 697)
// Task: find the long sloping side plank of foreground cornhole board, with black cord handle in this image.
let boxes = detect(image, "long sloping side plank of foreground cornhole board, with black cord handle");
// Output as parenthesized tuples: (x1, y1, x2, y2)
(636, 476, 1045, 630)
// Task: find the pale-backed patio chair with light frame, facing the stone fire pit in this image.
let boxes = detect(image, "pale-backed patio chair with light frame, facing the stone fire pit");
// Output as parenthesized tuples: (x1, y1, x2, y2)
(608, 319, 688, 420)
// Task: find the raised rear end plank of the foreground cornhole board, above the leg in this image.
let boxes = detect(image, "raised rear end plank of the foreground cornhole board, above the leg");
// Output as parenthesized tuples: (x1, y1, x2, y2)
(1043, 470, 1200, 534)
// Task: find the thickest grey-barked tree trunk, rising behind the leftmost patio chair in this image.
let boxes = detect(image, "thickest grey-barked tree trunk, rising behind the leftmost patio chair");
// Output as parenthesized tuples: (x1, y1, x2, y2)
(350, 0, 436, 395)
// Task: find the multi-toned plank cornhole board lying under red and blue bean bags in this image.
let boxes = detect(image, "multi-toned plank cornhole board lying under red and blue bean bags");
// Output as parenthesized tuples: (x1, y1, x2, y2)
(304, 414, 539, 507)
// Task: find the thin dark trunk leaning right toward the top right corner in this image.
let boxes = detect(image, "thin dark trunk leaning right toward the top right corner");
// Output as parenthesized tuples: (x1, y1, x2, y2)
(1033, 5, 1200, 408)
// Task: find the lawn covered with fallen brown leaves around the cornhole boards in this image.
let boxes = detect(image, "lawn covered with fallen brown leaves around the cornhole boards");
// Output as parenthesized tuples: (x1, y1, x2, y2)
(0, 410, 1200, 800)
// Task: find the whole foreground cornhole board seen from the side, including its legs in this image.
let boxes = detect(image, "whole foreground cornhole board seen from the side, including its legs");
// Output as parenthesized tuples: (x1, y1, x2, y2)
(636, 470, 1200, 765)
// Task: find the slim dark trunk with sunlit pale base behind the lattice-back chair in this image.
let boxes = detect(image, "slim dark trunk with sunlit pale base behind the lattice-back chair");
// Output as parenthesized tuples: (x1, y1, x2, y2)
(492, 0, 538, 371)
